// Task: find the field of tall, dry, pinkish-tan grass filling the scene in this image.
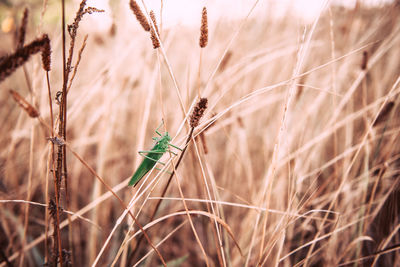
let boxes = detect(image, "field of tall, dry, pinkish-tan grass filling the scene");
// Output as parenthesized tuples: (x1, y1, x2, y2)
(0, 1, 400, 266)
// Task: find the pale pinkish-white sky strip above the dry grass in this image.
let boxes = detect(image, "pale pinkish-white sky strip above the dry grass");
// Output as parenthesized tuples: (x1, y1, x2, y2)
(83, 0, 392, 31)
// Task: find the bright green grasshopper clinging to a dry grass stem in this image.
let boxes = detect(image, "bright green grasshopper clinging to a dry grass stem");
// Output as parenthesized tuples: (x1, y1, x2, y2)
(128, 125, 182, 186)
